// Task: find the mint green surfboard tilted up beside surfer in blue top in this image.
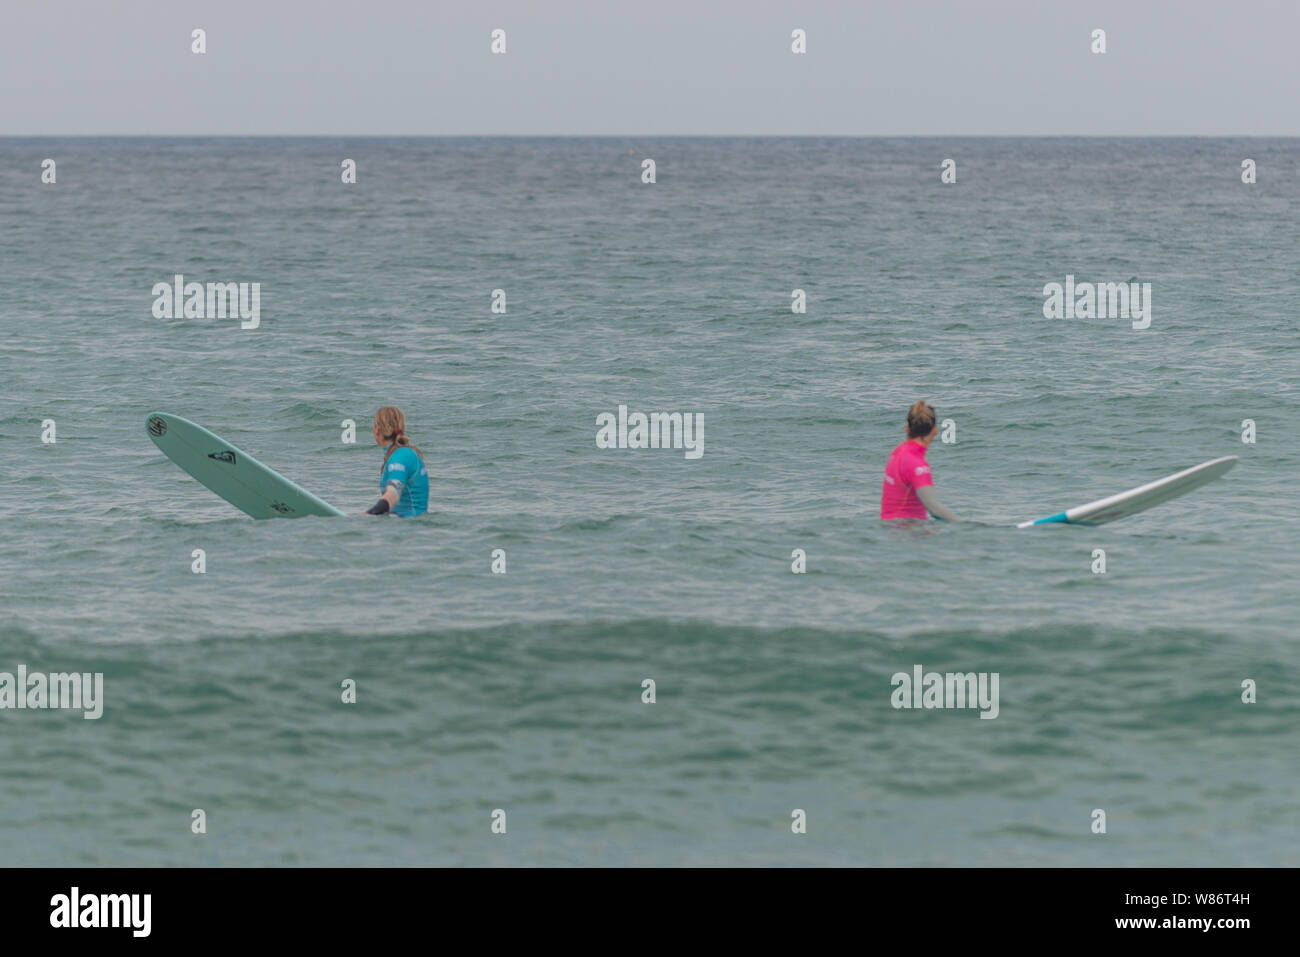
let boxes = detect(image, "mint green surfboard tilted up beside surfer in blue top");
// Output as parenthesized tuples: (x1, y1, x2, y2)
(144, 412, 343, 519)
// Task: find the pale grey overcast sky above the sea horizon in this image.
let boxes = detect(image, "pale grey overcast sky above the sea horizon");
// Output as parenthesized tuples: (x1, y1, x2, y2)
(0, 0, 1300, 135)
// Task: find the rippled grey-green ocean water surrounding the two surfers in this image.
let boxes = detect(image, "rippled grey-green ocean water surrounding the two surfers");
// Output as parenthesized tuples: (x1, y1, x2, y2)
(0, 138, 1300, 866)
